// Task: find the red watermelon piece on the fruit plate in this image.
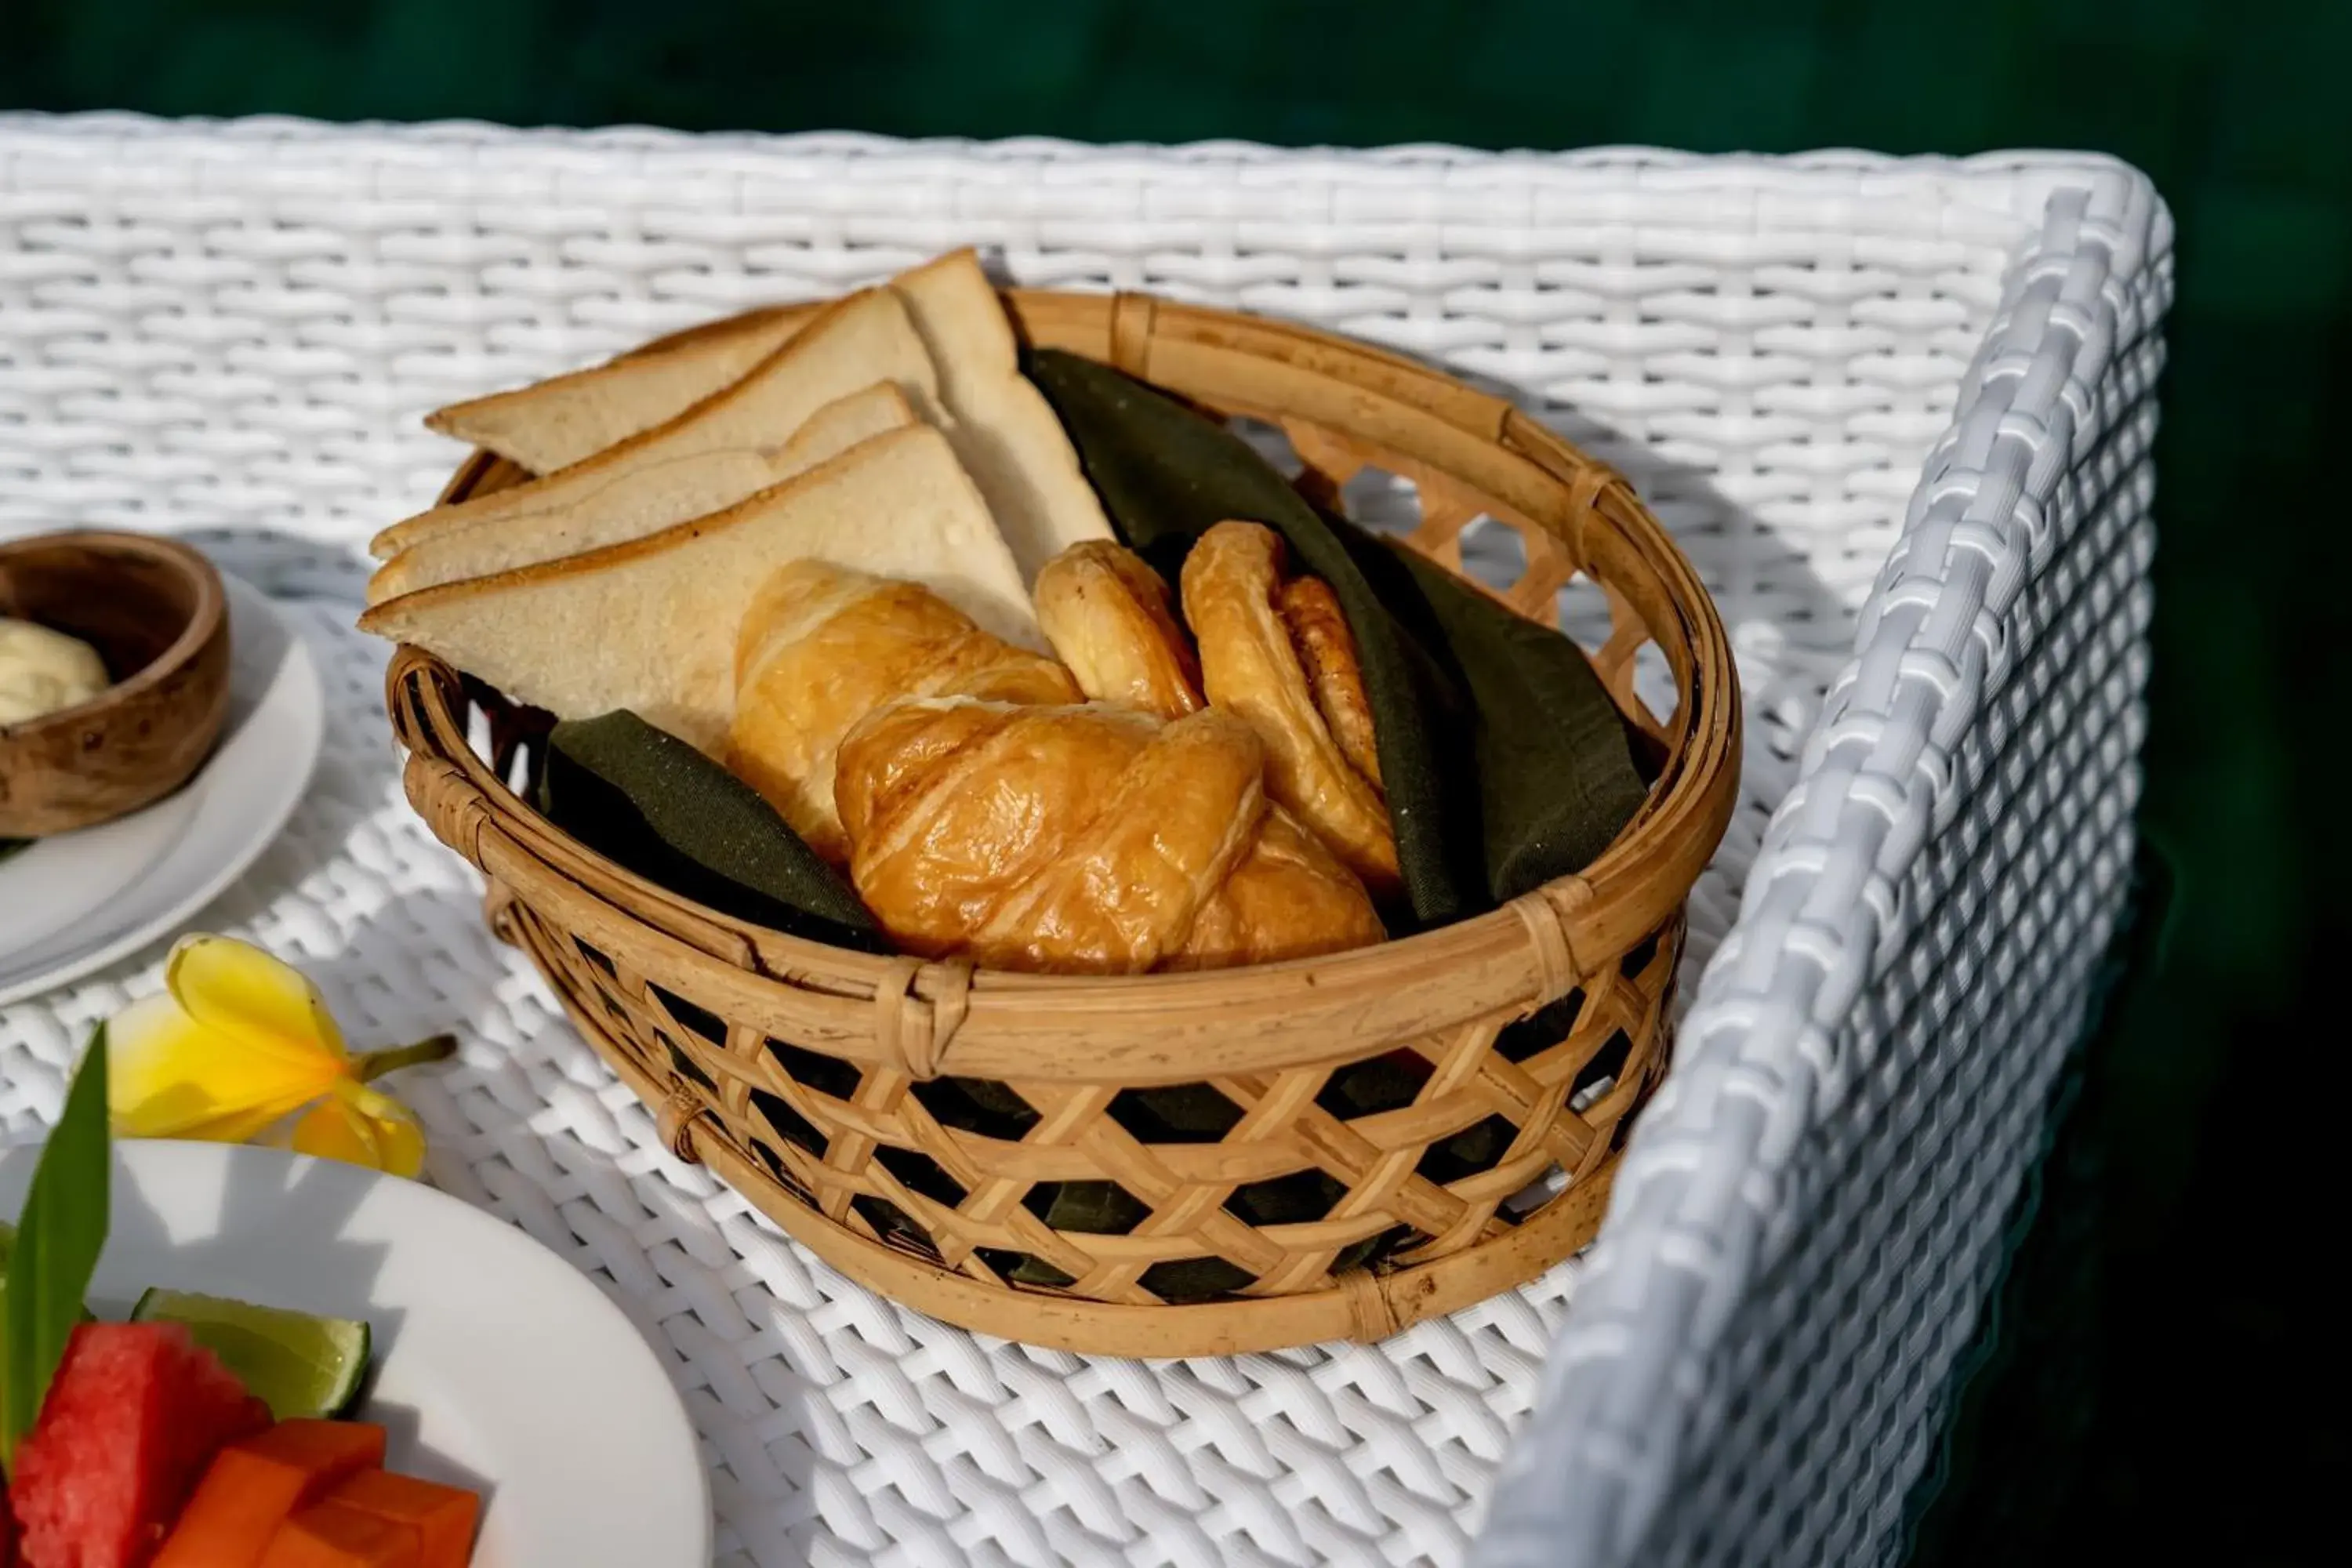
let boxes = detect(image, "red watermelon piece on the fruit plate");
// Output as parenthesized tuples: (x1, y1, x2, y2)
(9, 1323, 270, 1568)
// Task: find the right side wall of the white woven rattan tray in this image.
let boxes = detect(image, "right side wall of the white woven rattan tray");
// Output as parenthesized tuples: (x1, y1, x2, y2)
(1477, 169, 2171, 1568)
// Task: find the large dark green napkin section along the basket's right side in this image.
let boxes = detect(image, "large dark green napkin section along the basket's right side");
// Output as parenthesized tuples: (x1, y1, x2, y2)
(1030, 350, 1646, 926)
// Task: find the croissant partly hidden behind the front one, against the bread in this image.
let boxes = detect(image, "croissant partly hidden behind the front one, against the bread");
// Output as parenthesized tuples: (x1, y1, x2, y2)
(727, 560, 1080, 862)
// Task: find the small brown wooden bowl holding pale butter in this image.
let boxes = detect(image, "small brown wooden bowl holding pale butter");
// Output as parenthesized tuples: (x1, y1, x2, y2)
(0, 532, 228, 839)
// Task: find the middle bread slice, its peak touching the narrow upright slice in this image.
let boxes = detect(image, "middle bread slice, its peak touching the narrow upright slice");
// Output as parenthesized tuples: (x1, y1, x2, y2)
(367, 289, 943, 560)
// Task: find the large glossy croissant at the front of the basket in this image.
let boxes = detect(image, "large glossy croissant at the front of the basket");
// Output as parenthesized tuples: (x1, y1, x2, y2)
(835, 699, 1383, 973)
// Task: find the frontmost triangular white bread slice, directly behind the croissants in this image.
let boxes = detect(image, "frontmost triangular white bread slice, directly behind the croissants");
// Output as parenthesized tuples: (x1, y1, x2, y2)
(360, 426, 1044, 753)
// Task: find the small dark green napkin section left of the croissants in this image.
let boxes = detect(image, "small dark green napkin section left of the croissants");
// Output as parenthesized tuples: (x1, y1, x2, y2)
(539, 710, 889, 952)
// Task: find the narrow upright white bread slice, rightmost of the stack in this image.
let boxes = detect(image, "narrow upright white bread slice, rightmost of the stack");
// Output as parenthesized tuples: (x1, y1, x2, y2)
(891, 249, 1112, 583)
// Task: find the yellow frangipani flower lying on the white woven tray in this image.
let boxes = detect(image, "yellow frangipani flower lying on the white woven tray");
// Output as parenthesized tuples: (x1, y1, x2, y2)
(106, 935, 456, 1175)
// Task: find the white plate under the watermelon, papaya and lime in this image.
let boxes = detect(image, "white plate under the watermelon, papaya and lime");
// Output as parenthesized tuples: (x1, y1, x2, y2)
(0, 1142, 710, 1568)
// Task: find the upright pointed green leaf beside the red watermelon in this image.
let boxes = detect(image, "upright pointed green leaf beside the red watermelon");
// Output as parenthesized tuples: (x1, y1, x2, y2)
(0, 1025, 111, 1465)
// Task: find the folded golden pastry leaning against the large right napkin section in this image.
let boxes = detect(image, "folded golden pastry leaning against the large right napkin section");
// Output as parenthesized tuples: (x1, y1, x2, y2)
(1183, 522, 1402, 895)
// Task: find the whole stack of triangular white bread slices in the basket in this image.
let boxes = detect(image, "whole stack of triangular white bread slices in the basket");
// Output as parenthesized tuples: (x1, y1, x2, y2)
(360, 249, 1112, 753)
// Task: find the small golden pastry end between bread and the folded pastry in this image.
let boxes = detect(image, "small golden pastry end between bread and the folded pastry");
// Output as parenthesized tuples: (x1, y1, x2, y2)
(1035, 539, 1204, 720)
